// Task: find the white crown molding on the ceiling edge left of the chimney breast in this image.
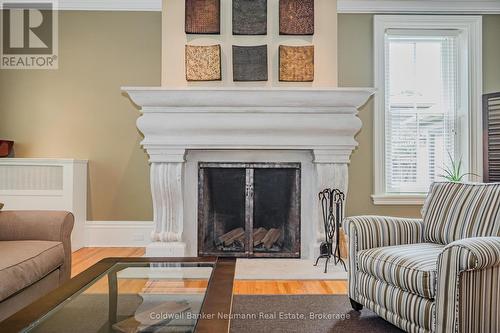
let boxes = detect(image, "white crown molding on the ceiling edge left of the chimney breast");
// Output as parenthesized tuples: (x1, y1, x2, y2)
(58, 0, 162, 11)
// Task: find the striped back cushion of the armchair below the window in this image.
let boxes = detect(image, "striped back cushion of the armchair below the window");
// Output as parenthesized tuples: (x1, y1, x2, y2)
(422, 183, 500, 244)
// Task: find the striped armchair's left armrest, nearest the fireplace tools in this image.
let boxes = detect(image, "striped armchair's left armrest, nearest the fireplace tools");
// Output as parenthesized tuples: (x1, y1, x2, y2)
(344, 216, 424, 302)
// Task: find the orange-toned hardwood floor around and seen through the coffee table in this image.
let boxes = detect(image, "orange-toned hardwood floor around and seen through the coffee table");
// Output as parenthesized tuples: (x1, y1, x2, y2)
(71, 247, 347, 295)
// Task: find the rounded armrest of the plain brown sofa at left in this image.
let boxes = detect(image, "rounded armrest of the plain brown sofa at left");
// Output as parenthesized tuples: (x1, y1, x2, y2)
(0, 211, 74, 283)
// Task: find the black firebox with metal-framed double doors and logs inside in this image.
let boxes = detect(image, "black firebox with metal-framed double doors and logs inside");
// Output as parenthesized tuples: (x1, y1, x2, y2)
(198, 162, 301, 258)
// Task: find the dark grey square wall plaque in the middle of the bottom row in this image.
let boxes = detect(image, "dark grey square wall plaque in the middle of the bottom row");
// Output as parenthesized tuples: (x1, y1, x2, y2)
(233, 45, 267, 81)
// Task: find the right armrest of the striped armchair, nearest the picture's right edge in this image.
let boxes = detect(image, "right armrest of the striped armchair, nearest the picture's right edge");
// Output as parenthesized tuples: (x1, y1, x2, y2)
(436, 237, 500, 333)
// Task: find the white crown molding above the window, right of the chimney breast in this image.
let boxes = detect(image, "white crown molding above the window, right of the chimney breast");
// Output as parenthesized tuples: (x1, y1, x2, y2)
(337, 0, 500, 14)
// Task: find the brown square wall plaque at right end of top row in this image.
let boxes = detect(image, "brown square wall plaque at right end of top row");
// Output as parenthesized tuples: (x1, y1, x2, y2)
(279, 0, 314, 35)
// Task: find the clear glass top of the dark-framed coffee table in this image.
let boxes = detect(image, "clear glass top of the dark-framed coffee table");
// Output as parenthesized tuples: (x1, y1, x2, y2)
(24, 262, 215, 333)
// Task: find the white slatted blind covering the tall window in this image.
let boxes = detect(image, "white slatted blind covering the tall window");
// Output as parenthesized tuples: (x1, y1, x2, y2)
(385, 30, 460, 193)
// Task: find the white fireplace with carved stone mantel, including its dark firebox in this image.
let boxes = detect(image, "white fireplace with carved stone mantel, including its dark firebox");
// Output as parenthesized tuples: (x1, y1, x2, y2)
(124, 87, 374, 259)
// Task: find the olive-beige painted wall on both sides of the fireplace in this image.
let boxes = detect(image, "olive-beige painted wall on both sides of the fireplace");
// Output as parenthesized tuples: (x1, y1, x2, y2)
(0, 11, 500, 220)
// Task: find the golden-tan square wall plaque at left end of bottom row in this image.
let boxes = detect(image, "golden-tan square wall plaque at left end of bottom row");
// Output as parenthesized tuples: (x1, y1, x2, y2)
(186, 45, 222, 81)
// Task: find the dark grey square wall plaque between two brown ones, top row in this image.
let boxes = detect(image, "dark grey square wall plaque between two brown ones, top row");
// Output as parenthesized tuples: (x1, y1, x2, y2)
(233, 0, 267, 35)
